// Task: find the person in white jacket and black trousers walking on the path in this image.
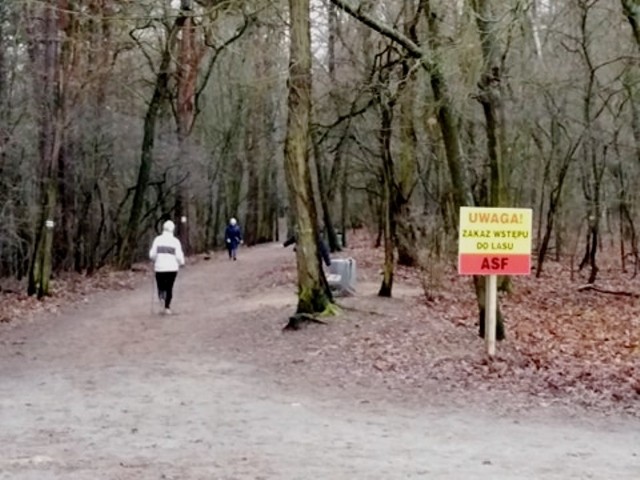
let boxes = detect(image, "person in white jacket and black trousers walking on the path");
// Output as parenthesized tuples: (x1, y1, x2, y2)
(149, 220, 184, 315)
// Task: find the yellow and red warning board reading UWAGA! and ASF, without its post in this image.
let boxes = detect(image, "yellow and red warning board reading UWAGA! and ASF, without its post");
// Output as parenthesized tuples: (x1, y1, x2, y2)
(458, 207, 533, 275)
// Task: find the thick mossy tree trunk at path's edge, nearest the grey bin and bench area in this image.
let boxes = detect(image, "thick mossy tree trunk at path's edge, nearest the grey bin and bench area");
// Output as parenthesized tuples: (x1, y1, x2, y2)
(285, 0, 332, 314)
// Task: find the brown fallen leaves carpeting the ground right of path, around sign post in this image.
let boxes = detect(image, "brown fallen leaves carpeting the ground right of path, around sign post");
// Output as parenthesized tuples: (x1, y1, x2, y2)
(240, 234, 640, 416)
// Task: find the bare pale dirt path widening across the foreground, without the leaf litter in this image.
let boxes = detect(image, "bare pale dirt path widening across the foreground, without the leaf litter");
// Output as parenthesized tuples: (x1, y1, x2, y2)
(0, 245, 640, 480)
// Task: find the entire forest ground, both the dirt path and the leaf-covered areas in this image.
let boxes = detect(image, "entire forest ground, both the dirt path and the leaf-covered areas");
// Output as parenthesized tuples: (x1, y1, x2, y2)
(0, 232, 640, 480)
